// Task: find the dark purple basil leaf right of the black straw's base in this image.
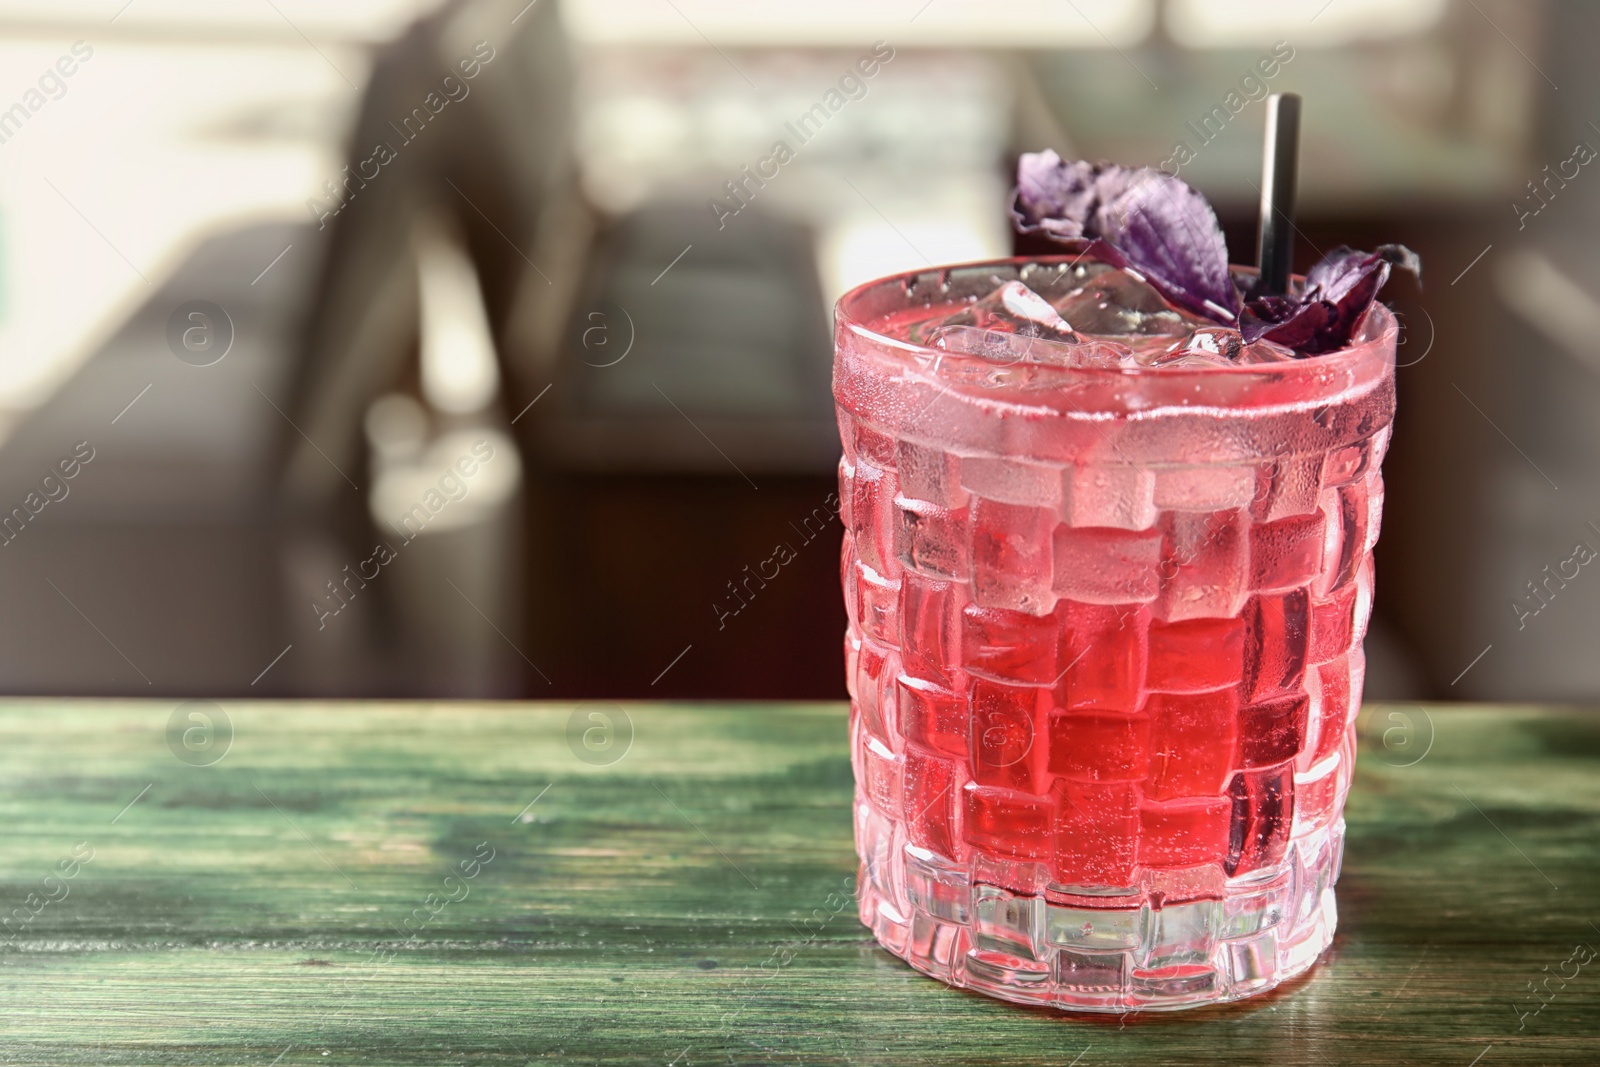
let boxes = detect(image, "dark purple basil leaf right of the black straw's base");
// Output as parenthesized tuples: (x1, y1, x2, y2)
(1240, 245, 1422, 355)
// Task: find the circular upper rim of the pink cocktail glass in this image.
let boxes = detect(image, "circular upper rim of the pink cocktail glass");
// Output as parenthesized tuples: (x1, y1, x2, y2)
(834, 253, 1400, 382)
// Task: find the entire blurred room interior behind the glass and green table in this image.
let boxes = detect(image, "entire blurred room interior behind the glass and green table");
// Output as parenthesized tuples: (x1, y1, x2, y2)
(0, 0, 1600, 699)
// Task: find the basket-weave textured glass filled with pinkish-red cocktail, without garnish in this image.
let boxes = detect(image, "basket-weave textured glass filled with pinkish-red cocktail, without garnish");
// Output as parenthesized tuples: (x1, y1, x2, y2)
(834, 261, 1395, 1011)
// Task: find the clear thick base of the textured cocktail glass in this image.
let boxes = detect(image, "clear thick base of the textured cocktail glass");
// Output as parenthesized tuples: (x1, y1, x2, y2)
(858, 819, 1344, 1013)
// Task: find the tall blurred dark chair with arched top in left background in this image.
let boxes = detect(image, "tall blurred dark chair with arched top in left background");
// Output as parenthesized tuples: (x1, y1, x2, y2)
(278, 0, 573, 696)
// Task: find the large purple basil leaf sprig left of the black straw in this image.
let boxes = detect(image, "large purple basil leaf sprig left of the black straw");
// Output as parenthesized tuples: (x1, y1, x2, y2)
(1011, 149, 1238, 325)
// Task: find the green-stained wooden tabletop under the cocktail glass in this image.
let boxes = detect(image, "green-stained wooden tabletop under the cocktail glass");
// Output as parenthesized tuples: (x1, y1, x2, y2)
(0, 701, 1600, 1067)
